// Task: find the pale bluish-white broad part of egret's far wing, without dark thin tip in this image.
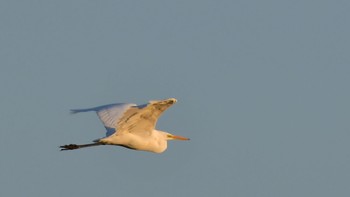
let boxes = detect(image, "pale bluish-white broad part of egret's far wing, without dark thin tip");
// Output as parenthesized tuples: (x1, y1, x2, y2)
(94, 103, 136, 136)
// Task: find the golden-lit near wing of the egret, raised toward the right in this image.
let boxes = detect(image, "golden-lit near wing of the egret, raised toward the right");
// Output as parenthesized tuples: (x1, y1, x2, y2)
(115, 99, 176, 136)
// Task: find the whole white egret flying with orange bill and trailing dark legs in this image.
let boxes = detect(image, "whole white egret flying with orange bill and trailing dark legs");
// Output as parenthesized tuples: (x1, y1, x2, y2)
(60, 98, 189, 153)
